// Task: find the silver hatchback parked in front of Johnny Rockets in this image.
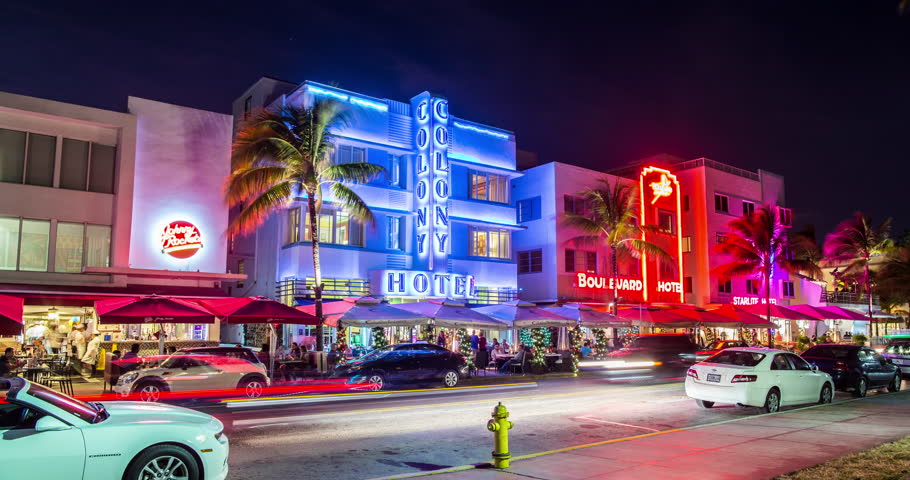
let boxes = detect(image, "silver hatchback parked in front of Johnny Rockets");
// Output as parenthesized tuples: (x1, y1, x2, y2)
(114, 353, 269, 402)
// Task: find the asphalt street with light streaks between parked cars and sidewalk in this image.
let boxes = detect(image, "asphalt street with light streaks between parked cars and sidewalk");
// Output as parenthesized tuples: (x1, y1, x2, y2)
(203, 376, 907, 480)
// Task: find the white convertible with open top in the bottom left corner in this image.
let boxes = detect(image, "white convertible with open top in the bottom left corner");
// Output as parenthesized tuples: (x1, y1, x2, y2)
(0, 377, 228, 480)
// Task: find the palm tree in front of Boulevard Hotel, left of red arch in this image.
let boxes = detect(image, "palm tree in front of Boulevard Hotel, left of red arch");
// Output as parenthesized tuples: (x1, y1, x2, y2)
(562, 178, 672, 315)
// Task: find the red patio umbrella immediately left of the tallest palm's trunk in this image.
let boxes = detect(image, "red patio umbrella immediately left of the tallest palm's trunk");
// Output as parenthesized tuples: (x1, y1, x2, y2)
(200, 297, 319, 325)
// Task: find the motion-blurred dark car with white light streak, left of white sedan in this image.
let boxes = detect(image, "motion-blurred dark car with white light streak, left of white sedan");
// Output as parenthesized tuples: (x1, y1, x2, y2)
(605, 333, 698, 369)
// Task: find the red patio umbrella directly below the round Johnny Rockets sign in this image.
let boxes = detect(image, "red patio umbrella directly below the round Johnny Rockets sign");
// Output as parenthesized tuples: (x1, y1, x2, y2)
(95, 295, 215, 324)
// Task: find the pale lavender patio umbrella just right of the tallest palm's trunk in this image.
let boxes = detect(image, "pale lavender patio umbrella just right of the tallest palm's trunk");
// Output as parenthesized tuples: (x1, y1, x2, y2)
(297, 297, 430, 328)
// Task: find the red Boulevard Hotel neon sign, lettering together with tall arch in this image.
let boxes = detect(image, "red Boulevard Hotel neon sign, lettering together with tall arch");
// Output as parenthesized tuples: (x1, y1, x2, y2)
(575, 167, 685, 302)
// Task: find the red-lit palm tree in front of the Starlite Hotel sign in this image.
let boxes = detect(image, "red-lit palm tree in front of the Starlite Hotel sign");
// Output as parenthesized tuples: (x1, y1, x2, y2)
(712, 205, 820, 345)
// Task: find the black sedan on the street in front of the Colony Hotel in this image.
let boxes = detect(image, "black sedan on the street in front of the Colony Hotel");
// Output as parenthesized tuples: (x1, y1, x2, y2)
(331, 343, 468, 390)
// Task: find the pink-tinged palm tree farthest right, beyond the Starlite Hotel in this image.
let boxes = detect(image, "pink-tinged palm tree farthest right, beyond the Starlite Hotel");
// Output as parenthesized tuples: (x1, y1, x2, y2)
(824, 212, 893, 335)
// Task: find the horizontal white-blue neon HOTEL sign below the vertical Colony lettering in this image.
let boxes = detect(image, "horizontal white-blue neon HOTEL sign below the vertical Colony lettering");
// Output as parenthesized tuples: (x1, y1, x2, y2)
(375, 270, 477, 298)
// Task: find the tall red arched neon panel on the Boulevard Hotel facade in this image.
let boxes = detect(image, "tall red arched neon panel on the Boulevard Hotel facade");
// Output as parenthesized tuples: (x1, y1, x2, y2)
(638, 167, 685, 303)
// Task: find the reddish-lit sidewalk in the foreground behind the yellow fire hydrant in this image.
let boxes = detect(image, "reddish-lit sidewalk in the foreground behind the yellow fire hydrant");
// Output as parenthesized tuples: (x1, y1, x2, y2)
(386, 391, 910, 480)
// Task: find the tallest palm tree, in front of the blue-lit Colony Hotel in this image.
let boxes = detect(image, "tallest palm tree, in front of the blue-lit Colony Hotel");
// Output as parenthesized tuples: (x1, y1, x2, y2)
(225, 100, 384, 351)
